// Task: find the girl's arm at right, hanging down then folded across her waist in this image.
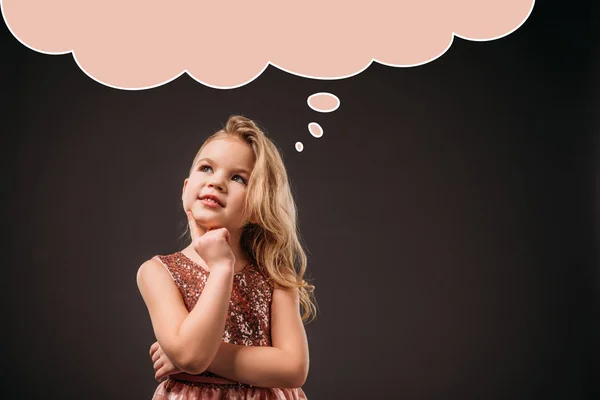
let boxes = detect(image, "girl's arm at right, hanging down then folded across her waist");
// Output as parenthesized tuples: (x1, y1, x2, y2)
(208, 286, 309, 388)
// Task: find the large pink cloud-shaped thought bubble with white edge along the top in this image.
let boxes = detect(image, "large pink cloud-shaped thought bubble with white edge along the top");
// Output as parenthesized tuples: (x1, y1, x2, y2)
(0, 0, 535, 90)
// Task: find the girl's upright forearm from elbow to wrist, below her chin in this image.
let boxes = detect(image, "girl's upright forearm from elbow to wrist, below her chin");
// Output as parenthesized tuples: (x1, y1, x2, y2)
(177, 269, 233, 374)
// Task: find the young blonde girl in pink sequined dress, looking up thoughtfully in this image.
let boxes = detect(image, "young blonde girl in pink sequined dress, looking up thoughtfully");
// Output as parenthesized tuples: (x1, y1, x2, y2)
(137, 116, 315, 400)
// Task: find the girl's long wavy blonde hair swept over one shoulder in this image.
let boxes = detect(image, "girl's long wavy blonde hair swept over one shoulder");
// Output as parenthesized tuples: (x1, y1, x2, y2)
(184, 115, 317, 323)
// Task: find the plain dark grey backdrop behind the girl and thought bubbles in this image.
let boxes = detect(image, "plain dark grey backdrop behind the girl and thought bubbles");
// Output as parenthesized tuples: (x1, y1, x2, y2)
(0, 2, 600, 400)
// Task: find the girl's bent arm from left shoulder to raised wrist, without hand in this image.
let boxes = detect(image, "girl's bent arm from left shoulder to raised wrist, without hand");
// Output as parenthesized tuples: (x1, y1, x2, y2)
(137, 259, 233, 374)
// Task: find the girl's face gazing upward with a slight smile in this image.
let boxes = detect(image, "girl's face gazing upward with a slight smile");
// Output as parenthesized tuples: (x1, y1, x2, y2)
(181, 137, 255, 231)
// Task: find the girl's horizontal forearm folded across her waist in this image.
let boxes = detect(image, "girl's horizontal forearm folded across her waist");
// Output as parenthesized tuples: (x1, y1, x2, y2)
(208, 342, 308, 388)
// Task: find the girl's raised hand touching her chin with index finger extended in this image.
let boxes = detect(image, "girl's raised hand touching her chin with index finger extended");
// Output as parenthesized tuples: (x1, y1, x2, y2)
(186, 211, 235, 271)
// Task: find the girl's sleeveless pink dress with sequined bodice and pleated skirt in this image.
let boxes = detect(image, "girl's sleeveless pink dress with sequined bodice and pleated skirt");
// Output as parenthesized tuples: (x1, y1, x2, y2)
(152, 252, 306, 400)
